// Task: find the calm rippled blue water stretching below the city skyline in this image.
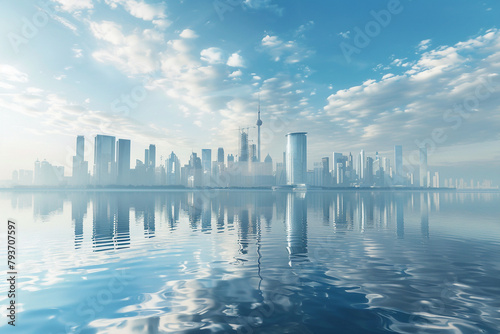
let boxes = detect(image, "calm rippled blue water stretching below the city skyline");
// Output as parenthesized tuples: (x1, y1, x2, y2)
(0, 191, 500, 334)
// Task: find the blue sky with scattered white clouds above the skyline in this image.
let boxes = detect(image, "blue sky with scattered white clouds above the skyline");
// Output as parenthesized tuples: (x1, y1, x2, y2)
(0, 0, 500, 183)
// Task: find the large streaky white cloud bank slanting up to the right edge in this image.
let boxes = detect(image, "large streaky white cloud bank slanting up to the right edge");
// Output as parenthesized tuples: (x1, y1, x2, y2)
(323, 30, 500, 158)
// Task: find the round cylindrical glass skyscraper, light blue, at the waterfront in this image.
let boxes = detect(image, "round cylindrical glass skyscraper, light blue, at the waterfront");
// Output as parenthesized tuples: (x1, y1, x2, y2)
(286, 132, 307, 185)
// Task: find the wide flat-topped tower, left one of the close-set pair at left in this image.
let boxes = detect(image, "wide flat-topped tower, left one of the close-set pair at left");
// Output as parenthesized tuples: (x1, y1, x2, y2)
(94, 135, 115, 185)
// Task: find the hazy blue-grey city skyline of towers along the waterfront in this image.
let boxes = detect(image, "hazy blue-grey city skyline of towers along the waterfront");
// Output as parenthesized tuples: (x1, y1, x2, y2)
(7, 107, 491, 188)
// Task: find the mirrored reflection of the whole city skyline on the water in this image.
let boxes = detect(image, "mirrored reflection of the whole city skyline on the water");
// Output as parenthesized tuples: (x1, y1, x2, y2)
(16, 192, 500, 253)
